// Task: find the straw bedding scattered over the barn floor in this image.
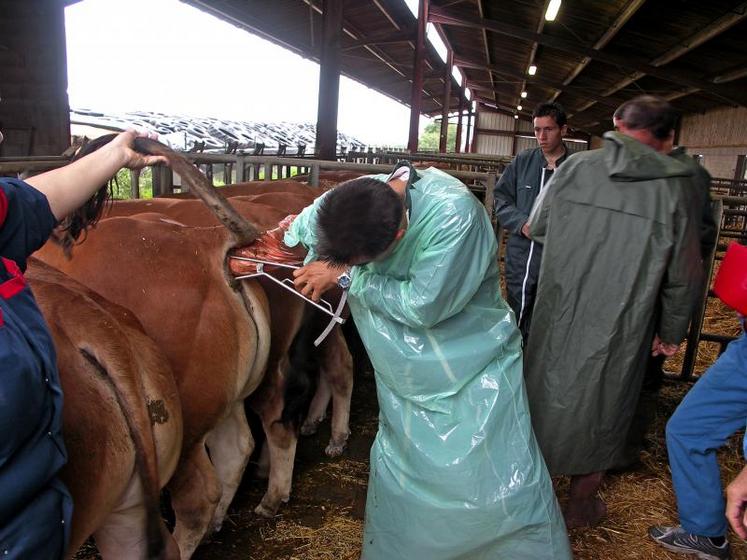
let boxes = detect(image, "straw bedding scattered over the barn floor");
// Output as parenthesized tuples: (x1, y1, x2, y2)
(82, 260, 747, 560)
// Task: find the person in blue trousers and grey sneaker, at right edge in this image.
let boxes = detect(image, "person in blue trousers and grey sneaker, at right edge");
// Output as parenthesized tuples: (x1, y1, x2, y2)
(649, 312, 747, 560)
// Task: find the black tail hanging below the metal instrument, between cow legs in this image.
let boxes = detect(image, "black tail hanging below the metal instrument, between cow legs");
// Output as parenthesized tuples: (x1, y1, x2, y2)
(280, 305, 319, 431)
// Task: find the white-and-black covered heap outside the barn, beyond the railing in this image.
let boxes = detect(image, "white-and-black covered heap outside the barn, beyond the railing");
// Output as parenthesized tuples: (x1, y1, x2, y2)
(70, 109, 365, 154)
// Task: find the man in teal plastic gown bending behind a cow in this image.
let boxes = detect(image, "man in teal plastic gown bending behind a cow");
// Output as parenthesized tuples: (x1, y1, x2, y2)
(285, 166, 571, 560)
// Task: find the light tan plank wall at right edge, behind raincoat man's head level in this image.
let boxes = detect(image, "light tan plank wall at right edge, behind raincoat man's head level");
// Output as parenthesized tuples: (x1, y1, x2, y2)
(678, 107, 747, 179)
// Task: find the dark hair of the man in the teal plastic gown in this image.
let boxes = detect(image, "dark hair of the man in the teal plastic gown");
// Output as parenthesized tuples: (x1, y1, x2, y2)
(317, 177, 404, 264)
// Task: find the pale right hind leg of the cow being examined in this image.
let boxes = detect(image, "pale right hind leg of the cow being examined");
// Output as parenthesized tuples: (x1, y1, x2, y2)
(207, 401, 254, 531)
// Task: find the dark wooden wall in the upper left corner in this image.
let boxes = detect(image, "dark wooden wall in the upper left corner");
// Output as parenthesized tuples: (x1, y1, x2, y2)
(0, 0, 70, 156)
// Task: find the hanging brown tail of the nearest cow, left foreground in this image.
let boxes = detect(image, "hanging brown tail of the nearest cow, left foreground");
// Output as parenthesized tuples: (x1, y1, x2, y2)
(78, 344, 165, 559)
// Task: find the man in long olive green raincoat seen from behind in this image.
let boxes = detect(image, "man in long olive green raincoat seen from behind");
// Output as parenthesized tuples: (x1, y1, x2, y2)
(525, 96, 702, 526)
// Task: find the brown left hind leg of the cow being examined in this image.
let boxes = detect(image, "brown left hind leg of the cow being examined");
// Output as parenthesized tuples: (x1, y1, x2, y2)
(169, 441, 221, 560)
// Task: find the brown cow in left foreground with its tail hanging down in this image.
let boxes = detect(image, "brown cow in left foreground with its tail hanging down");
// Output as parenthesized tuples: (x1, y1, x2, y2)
(26, 259, 182, 560)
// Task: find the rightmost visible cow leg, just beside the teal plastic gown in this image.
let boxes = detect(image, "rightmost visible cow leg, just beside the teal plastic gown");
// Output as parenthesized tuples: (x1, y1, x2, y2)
(321, 327, 353, 457)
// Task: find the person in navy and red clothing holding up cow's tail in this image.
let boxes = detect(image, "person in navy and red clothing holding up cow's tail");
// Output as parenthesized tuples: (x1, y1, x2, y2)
(0, 131, 163, 559)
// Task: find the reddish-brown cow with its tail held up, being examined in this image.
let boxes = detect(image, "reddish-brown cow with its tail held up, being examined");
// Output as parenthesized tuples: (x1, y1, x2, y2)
(37, 218, 274, 558)
